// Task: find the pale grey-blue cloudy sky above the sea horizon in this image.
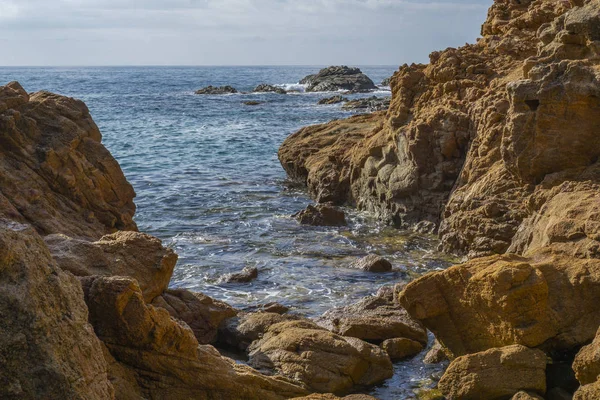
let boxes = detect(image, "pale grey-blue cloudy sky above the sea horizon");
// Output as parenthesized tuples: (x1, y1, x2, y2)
(0, 0, 492, 66)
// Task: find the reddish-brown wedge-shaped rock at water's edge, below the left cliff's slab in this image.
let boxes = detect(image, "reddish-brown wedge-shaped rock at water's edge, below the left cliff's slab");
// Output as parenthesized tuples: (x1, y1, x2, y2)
(152, 289, 237, 344)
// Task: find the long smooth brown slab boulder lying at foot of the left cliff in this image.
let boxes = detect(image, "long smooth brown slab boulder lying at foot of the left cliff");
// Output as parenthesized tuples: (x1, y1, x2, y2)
(44, 232, 177, 303)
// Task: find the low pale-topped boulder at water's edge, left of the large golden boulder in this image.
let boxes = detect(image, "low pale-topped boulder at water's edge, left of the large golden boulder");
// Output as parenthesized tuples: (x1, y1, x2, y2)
(317, 296, 427, 345)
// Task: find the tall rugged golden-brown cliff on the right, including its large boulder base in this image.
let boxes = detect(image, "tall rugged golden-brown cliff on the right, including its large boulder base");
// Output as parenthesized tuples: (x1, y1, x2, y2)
(279, 0, 600, 398)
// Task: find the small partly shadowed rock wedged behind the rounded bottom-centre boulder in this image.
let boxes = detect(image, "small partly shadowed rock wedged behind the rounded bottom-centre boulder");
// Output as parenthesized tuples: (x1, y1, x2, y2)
(219, 312, 301, 351)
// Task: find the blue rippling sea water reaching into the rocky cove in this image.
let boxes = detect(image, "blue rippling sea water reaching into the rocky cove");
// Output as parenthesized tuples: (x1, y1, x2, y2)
(0, 66, 447, 400)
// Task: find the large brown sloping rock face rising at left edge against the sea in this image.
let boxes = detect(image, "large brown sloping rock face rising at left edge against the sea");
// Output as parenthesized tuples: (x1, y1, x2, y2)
(0, 82, 137, 239)
